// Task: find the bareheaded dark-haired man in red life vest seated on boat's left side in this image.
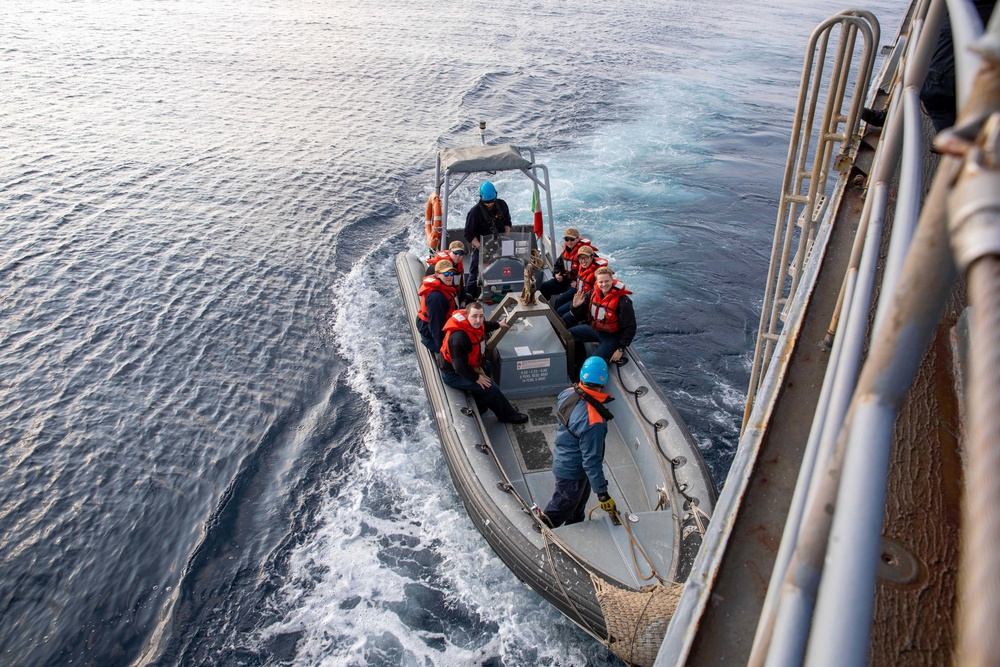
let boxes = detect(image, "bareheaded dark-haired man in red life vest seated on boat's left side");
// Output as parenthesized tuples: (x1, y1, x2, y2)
(441, 301, 528, 424)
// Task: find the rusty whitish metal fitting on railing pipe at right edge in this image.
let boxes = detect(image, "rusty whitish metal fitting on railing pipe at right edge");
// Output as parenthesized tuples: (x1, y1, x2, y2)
(948, 112, 1000, 273)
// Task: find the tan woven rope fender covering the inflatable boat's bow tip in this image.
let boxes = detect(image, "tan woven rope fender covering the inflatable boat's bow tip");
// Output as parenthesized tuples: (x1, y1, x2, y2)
(590, 574, 684, 667)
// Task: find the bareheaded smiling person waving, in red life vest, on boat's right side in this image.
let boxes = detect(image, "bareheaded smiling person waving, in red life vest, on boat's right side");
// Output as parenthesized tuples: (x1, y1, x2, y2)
(569, 266, 635, 362)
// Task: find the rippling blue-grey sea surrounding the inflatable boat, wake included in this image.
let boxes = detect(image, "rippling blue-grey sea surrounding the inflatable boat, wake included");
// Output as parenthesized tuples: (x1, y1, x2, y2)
(0, 0, 904, 666)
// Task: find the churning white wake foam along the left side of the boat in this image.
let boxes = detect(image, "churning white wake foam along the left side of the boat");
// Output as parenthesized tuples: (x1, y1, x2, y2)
(260, 239, 606, 666)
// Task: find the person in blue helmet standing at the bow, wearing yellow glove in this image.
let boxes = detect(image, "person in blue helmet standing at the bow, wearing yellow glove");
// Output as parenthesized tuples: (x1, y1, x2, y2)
(541, 357, 617, 528)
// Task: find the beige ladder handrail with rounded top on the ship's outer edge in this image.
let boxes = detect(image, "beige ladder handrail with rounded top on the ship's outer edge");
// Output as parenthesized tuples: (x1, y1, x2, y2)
(743, 10, 879, 427)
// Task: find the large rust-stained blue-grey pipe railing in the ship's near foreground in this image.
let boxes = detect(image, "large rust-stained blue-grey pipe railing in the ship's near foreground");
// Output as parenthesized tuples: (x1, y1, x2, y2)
(748, 0, 1000, 665)
